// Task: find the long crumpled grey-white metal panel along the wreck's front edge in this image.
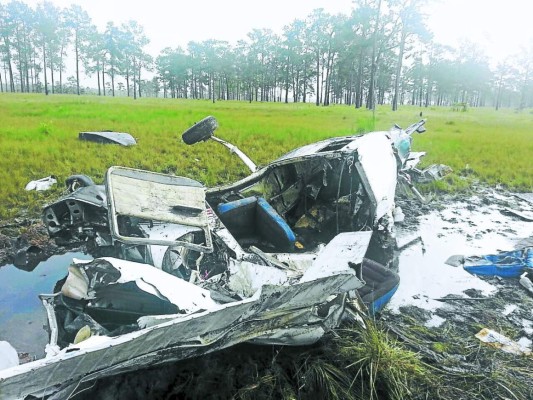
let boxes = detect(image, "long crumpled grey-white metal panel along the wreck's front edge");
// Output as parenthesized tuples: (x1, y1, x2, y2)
(0, 256, 362, 398)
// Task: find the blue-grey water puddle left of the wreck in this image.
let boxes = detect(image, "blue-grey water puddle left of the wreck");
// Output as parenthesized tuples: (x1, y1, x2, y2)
(0, 252, 92, 359)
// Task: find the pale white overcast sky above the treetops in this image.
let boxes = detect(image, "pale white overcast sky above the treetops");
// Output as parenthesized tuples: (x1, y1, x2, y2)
(20, 0, 533, 62)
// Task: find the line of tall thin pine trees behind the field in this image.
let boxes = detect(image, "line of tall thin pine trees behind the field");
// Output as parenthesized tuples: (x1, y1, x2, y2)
(0, 0, 533, 110)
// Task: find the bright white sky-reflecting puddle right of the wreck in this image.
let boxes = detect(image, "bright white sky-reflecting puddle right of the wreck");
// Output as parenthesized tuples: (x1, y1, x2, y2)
(389, 194, 533, 311)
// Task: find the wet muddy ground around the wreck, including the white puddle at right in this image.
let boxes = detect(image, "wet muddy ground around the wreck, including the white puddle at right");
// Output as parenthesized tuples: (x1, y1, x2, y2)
(0, 187, 533, 400)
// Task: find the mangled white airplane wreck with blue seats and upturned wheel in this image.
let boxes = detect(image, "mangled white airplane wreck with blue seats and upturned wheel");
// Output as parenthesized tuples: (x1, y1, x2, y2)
(0, 117, 432, 398)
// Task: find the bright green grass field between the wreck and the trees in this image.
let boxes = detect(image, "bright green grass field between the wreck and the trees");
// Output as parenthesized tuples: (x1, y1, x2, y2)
(0, 93, 533, 218)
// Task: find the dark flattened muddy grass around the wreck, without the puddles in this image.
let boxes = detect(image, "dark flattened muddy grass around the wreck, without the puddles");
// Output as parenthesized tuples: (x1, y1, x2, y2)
(4, 188, 533, 400)
